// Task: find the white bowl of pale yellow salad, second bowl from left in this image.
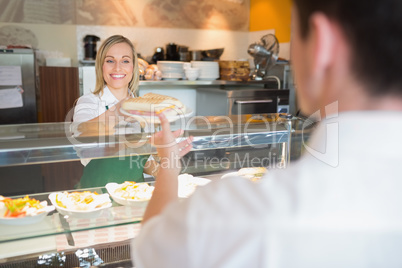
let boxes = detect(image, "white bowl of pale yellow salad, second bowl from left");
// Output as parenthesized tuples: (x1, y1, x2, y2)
(49, 191, 112, 218)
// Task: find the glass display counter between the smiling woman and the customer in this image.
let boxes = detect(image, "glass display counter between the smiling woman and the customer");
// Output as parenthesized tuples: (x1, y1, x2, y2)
(0, 114, 312, 267)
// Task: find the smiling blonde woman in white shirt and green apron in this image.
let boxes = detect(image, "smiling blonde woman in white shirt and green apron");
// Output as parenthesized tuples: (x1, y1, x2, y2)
(73, 35, 156, 188)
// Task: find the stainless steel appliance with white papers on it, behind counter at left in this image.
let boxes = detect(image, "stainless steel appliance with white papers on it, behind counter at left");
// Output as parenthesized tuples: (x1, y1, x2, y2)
(0, 49, 38, 125)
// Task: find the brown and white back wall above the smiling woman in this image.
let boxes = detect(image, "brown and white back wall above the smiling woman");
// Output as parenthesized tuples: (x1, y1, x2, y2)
(0, 0, 286, 66)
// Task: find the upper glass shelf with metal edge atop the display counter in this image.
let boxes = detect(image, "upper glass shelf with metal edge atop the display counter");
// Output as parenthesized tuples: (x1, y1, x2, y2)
(0, 114, 299, 167)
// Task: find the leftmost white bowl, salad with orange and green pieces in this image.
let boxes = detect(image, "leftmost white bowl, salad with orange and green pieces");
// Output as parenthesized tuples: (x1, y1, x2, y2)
(0, 195, 54, 225)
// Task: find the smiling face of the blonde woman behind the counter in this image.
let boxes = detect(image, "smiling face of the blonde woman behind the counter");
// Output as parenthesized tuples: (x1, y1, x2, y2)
(102, 43, 134, 91)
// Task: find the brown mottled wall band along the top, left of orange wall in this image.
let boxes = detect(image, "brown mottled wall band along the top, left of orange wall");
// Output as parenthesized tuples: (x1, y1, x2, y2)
(0, 0, 250, 31)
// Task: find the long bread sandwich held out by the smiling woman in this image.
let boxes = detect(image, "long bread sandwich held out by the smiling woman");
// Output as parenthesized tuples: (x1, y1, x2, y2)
(122, 93, 186, 116)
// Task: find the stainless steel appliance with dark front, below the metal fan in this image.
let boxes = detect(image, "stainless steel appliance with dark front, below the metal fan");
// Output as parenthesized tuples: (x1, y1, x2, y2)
(196, 63, 295, 116)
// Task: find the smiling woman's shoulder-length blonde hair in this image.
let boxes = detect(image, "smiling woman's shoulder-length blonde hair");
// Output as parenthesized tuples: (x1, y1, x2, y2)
(93, 35, 140, 97)
